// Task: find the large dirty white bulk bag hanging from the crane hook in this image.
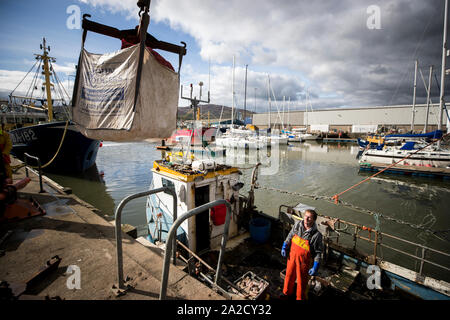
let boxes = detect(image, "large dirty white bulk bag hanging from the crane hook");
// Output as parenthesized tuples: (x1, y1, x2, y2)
(73, 44, 179, 141)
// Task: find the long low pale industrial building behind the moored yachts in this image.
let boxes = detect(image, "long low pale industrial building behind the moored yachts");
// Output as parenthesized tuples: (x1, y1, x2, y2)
(253, 104, 448, 133)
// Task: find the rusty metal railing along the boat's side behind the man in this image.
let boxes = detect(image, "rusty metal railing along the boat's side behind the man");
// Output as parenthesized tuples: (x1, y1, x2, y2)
(279, 206, 450, 277)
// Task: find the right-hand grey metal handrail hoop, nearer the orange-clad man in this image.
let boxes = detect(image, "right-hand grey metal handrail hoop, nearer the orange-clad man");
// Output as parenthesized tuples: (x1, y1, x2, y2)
(159, 200, 231, 300)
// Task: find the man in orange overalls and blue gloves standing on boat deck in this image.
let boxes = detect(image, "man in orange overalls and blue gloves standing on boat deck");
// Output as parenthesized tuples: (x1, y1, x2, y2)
(281, 209, 323, 300)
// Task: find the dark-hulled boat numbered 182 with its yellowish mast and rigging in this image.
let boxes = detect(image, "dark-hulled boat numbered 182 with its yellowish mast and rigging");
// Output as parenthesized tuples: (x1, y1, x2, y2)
(9, 38, 100, 173)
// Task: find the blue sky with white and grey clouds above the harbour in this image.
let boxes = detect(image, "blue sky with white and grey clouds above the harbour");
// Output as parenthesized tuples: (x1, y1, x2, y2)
(0, 0, 450, 112)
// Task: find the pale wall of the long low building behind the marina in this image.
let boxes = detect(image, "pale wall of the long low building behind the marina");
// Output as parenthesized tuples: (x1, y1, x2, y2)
(253, 104, 447, 132)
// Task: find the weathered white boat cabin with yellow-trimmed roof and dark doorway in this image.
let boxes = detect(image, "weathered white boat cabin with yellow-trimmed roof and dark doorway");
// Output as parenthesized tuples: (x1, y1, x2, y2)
(146, 160, 243, 253)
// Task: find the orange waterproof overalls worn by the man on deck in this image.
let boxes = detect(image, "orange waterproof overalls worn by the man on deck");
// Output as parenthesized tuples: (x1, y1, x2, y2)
(283, 235, 311, 300)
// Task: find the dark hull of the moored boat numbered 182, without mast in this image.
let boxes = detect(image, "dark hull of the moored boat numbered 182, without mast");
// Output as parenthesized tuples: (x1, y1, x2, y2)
(10, 121, 100, 173)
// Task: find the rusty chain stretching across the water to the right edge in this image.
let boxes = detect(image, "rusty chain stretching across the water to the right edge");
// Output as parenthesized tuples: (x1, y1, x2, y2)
(255, 184, 450, 242)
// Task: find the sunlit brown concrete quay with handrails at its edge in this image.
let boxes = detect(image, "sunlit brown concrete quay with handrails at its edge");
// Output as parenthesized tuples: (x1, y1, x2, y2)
(0, 159, 224, 300)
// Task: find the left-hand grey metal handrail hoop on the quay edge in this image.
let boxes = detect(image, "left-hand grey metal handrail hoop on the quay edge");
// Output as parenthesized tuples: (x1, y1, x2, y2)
(115, 187, 177, 289)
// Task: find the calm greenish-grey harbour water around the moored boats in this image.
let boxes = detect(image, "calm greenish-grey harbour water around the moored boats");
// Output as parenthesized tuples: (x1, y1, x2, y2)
(48, 142, 450, 281)
